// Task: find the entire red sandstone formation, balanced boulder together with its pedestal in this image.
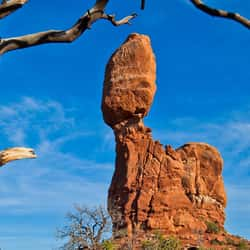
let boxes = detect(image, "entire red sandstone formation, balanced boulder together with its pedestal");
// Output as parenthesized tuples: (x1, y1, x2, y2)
(102, 34, 229, 246)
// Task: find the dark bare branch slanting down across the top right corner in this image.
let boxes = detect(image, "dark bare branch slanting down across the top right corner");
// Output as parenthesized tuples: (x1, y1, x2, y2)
(190, 0, 250, 29)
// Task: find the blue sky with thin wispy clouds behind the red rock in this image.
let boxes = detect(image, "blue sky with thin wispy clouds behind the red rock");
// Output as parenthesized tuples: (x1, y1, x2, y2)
(0, 0, 250, 250)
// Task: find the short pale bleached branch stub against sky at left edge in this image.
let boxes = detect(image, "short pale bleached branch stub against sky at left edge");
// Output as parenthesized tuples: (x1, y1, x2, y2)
(0, 148, 36, 166)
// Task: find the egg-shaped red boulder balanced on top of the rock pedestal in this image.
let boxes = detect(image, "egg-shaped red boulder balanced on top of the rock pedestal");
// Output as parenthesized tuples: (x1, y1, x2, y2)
(102, 34, 156, 126)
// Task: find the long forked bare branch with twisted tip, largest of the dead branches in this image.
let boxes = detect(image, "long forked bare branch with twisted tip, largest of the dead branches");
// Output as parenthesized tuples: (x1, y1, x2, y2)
(0, 0, 136, 55)
